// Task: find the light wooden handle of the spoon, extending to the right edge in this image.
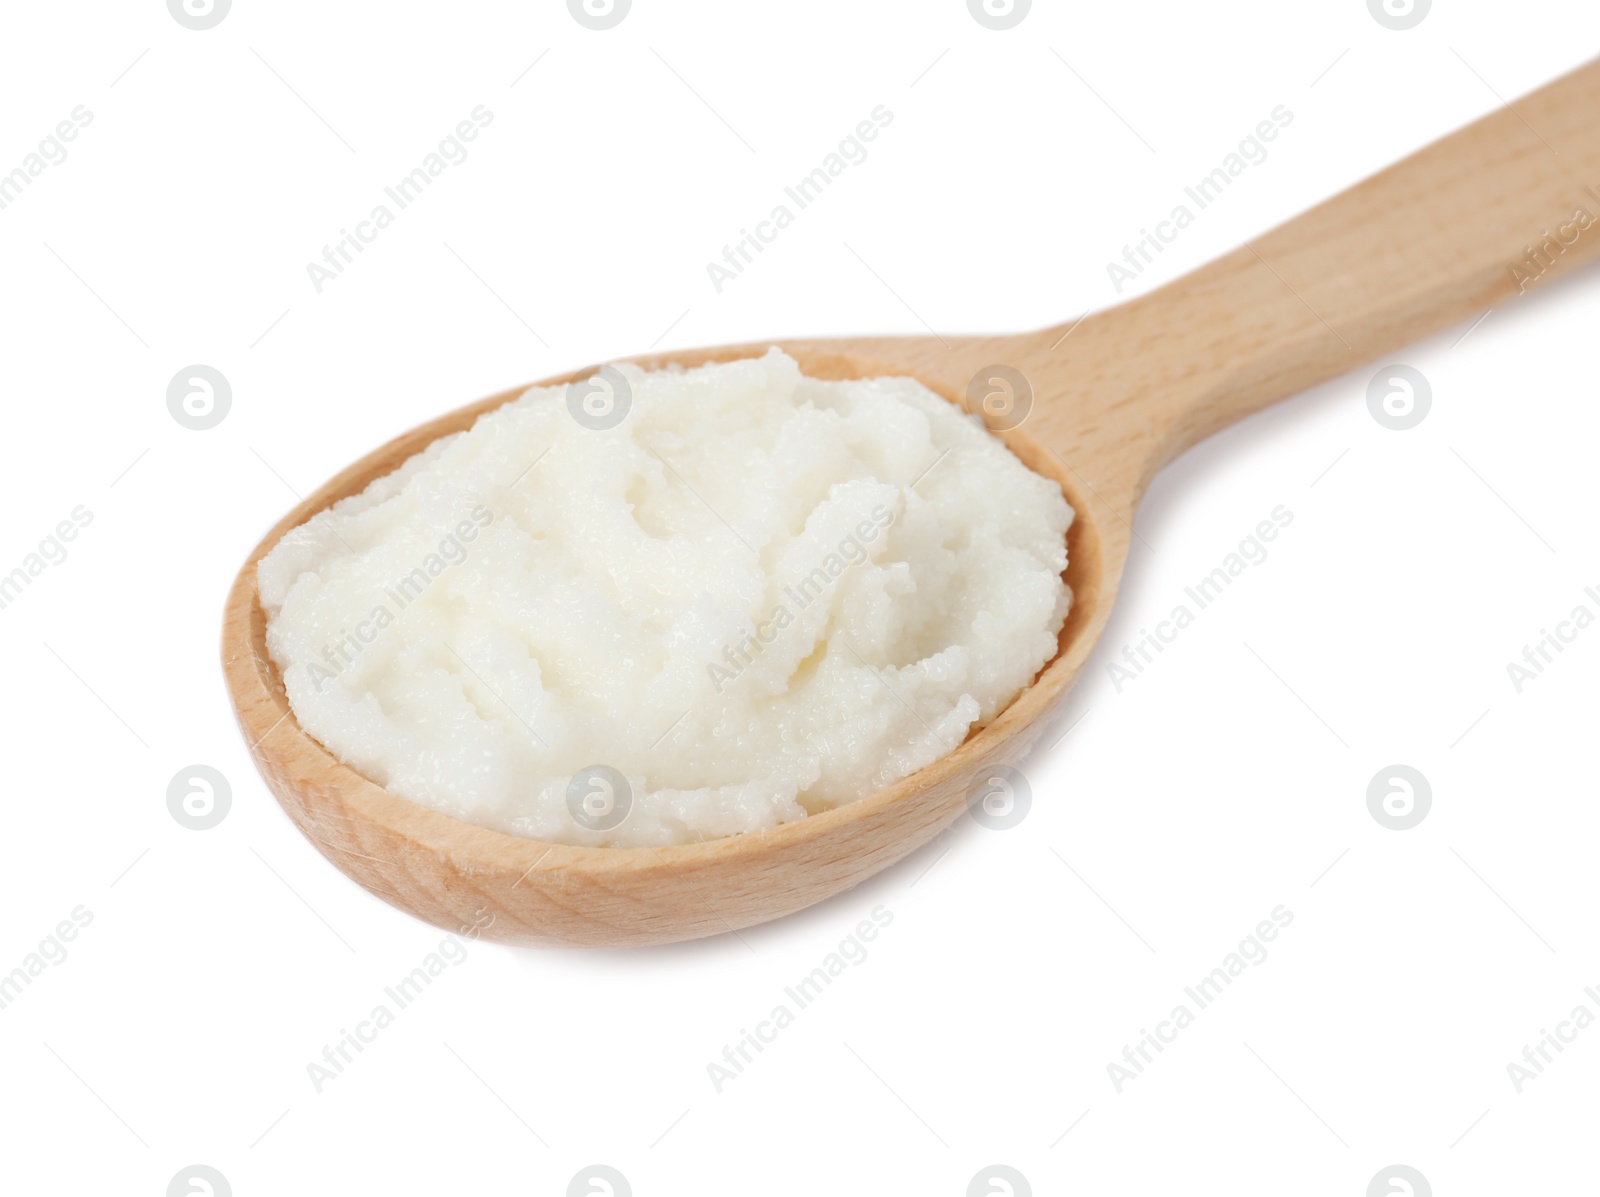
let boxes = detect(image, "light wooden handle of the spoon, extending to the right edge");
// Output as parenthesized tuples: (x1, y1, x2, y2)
(1029, 62, 1600, 501)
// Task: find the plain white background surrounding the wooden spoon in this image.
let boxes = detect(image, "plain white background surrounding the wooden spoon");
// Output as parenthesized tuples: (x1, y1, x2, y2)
(0, 0, 1600, 1197)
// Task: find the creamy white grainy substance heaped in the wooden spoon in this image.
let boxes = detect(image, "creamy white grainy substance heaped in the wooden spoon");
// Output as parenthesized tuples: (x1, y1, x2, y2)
(259, 349, 1072, 847)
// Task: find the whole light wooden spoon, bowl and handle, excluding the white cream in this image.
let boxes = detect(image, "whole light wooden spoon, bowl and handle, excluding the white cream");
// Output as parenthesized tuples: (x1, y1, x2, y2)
(222, 64, 1600, 946)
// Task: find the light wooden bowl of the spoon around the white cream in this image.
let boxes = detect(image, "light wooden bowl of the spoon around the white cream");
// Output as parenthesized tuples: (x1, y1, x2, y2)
(222, 338, 1120, 946)
